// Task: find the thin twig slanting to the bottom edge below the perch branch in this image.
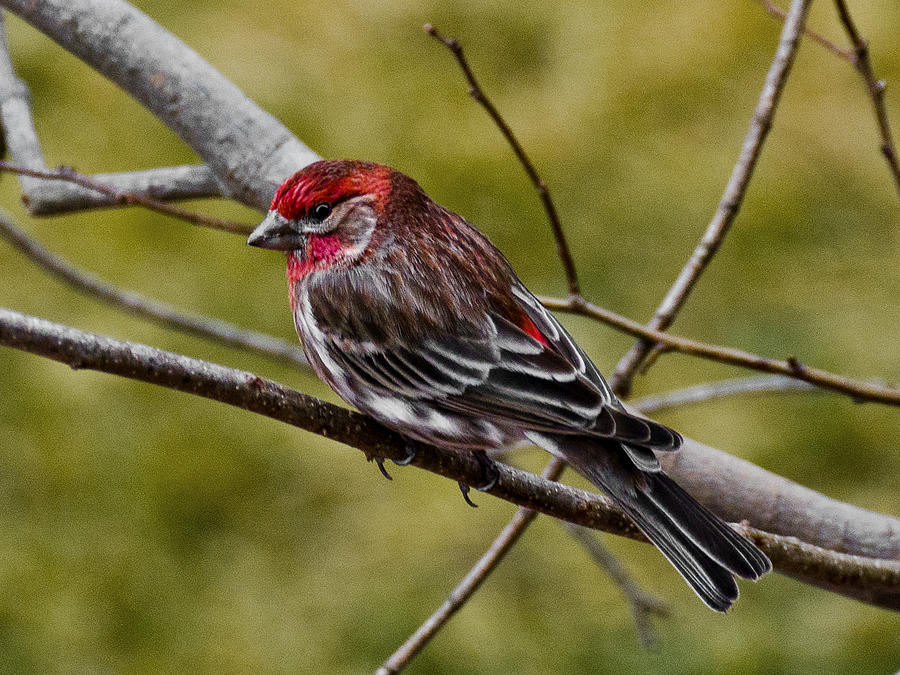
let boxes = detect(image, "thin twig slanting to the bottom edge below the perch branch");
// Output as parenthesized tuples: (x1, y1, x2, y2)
(376, 458, 566, 675)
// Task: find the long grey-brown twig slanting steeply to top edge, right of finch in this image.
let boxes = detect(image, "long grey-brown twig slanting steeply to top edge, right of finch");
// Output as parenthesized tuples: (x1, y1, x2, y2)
(610, 0, 810, 396)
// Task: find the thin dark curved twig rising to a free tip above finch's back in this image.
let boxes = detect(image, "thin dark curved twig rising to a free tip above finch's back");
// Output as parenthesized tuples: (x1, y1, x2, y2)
(424, 23, 581, 297)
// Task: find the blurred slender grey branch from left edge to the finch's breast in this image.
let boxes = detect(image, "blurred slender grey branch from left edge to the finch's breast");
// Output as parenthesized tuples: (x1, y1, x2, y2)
(0, 209, 309, 368)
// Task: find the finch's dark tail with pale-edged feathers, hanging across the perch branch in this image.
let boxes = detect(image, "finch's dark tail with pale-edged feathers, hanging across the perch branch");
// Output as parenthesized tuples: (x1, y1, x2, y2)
(541, 436, 772, 612)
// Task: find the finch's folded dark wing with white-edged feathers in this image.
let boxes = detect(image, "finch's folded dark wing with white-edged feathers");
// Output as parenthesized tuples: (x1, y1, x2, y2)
(312, 278, 681, 456)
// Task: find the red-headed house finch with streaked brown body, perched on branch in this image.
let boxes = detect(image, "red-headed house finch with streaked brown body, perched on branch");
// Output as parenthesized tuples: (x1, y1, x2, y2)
(248, 161, 772, 611)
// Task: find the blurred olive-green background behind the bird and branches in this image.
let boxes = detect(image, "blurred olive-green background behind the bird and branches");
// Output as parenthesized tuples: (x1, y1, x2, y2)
(0, 0, 900, 673)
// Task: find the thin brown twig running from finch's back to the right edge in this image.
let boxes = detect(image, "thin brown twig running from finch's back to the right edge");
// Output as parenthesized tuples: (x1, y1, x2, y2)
(540, 297, 900, 405)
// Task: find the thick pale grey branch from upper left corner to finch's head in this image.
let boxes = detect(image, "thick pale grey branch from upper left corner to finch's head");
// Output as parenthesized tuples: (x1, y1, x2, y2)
(0, 0, 319, 209)
